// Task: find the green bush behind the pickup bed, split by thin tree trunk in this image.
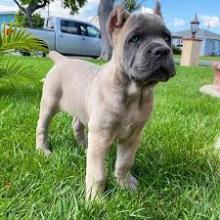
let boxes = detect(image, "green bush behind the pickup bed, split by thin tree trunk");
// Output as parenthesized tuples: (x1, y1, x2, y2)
(15, 11, 44, 28)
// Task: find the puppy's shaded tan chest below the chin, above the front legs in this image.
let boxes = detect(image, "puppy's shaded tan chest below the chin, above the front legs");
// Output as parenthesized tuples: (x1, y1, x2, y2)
(109, 83, 153, 139)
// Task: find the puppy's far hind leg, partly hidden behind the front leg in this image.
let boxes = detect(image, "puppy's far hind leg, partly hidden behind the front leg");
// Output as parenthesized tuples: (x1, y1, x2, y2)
(72, 119, 87, 148)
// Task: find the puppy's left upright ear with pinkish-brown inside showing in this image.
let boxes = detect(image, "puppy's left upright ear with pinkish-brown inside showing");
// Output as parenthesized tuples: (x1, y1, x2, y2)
(107, 6, 130, 35)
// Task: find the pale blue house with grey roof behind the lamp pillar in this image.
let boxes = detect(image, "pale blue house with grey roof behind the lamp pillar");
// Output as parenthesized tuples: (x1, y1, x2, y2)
(172, 29, 220, 56)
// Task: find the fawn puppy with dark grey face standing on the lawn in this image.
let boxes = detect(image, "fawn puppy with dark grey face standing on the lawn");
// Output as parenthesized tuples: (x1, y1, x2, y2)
(36, 4, 175, 199)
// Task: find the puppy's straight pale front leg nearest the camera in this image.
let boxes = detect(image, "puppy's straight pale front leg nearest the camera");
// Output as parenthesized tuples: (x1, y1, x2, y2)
(86, 131, 113, 200)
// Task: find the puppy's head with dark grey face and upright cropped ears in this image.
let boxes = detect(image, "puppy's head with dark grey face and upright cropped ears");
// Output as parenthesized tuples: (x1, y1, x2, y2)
(108, 3, 176, 85)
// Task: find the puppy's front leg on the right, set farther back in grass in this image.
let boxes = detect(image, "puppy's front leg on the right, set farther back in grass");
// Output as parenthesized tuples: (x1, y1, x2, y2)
(115, 132, 141, 190)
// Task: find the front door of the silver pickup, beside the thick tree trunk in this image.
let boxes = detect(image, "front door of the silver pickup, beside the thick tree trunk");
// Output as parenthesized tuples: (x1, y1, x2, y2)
(80, 24, 101, 57)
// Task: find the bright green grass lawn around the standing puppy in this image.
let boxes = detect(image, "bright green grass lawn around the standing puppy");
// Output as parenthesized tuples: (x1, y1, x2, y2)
(0, 55, 220, 220)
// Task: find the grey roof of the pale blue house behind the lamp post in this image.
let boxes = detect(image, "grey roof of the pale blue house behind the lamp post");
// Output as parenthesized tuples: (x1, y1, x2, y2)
(173, 29, 220, 40)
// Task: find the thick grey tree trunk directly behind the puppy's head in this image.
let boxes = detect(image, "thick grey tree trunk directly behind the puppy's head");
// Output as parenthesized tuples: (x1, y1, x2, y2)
(98, 0, 114, 60)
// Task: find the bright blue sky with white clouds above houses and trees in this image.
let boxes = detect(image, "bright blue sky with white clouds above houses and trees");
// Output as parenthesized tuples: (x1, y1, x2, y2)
(0, 0, 220, 34)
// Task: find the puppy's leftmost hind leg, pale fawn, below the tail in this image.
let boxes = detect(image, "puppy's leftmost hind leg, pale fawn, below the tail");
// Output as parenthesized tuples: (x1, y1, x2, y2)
(36, 97, 57, 156)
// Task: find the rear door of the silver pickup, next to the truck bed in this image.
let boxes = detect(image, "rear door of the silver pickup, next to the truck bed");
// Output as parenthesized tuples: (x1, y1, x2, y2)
(56, 19, 85, 55)
